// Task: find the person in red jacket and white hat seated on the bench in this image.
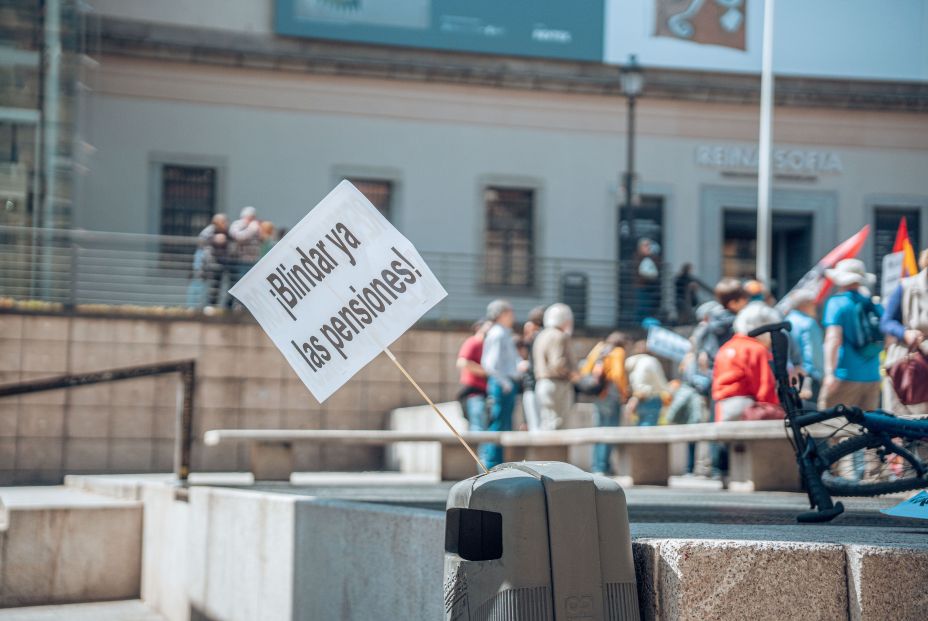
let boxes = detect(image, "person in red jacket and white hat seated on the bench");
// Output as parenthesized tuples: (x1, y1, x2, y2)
(712, 302, 782, 422)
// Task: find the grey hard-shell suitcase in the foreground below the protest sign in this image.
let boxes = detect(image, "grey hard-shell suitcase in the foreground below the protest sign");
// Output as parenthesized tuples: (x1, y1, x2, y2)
(444, 462, 639, 621)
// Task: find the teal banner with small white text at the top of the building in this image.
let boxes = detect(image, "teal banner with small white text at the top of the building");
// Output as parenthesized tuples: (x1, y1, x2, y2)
(275, 0, 604, 62)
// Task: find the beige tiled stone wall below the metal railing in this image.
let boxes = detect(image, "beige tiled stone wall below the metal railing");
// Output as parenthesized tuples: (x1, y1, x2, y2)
(0, 313, 600, 485)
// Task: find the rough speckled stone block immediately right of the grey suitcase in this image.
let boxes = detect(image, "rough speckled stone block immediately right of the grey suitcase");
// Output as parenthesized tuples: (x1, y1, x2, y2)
(639, 539, 848, 621)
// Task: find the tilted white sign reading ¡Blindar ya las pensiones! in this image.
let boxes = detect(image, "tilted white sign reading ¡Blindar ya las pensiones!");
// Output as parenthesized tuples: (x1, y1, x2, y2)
(231, 181, 448, 402)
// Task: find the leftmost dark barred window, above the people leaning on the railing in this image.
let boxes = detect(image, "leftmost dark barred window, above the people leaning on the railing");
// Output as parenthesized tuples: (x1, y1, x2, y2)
(161, 164, 216, 237)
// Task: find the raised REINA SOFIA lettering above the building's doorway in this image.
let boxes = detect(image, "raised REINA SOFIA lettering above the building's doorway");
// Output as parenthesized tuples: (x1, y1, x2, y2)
(696, 145, 844, 174)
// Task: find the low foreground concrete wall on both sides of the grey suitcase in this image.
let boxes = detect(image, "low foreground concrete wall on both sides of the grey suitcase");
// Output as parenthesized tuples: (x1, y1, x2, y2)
(32, 477, 928, 621)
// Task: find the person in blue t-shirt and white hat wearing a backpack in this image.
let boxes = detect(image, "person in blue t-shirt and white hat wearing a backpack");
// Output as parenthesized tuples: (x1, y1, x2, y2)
(818, 259, 883, 410)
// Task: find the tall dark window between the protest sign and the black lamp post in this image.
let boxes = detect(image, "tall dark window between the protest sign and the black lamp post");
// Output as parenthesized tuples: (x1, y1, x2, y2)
(484, 188, 535, 289)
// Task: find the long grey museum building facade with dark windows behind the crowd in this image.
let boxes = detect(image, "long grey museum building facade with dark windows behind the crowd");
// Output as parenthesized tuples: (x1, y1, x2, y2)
(1, 0, 928, 326)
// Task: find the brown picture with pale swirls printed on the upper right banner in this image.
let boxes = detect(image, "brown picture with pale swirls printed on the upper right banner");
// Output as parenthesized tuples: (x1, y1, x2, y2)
(654, 0, 747, 50)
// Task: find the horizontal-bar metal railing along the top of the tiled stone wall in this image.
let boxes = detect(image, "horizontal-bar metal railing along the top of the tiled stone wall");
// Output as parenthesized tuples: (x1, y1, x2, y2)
(0, 226, 704, 328)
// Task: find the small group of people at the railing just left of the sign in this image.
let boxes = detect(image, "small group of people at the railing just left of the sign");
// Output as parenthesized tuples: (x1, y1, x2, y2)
(187, 207, 284, 313)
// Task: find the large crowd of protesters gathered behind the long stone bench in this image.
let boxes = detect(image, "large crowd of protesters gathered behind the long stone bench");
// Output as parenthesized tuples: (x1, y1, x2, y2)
(457, 251, 928, 478)
